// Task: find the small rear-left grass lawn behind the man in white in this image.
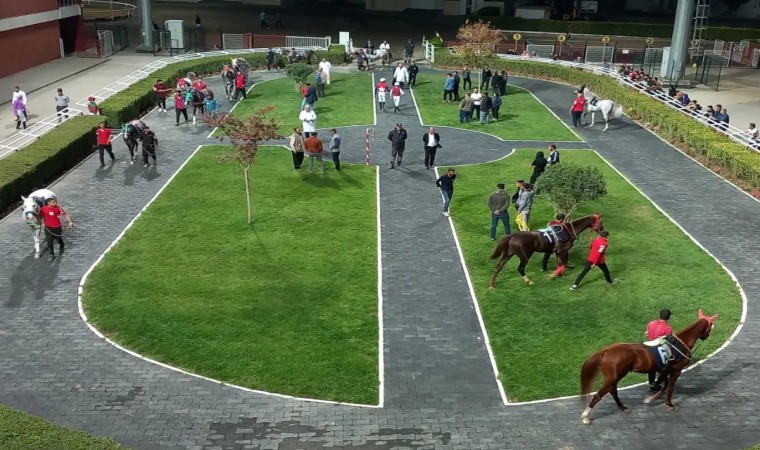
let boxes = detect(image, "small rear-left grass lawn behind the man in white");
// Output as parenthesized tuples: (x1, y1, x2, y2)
(233, 73, 375, 136)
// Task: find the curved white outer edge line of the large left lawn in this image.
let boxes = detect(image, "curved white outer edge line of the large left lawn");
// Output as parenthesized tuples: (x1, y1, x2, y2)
(77, 145, 382, 408)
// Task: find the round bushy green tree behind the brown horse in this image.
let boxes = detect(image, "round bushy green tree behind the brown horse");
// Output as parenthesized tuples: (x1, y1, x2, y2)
(534, 162, 607, 217)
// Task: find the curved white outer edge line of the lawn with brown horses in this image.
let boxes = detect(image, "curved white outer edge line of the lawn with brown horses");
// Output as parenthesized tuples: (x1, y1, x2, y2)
(504, 149, 754, 405)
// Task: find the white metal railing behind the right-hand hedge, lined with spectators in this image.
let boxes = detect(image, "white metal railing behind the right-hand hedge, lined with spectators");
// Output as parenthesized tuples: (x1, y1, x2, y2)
(499, 54, 760, 153)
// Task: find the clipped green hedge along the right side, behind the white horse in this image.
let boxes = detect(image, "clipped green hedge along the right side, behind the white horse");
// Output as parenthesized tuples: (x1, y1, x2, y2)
(435, 52, 760, 189)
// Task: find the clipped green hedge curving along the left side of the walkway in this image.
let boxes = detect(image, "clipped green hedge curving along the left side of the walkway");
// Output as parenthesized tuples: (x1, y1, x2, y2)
(0, 50, 345, 212)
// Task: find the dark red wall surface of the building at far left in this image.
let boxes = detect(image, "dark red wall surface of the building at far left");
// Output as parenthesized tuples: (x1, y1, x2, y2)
(0, 22, 61, 78)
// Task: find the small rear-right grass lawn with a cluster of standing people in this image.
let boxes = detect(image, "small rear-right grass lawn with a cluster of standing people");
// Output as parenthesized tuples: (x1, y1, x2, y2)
(414, 74, 579, 141)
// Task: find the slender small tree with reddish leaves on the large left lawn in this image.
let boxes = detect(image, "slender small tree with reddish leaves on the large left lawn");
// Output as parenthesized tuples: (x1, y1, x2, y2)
(203, 106, 283, 225)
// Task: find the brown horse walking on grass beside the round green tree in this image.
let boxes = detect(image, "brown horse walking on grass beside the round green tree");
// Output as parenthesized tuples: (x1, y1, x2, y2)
(489, 213, 604, 289)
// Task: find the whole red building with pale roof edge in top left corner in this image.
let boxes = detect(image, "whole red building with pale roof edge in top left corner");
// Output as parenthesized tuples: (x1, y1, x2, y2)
(0, 0, 83, 77)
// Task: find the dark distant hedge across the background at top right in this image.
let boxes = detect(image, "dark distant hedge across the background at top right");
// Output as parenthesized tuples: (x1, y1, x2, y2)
(477, 16, 760, 42)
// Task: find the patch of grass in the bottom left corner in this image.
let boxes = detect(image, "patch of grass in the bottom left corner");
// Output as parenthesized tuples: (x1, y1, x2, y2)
(0, 405, 127, 450)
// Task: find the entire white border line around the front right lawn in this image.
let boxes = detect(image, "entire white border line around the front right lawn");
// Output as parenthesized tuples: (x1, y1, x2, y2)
(446, 149, 748, 406)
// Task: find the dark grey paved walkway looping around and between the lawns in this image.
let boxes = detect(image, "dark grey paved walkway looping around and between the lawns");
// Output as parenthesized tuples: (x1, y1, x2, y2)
(0, 67, 760, 449)
